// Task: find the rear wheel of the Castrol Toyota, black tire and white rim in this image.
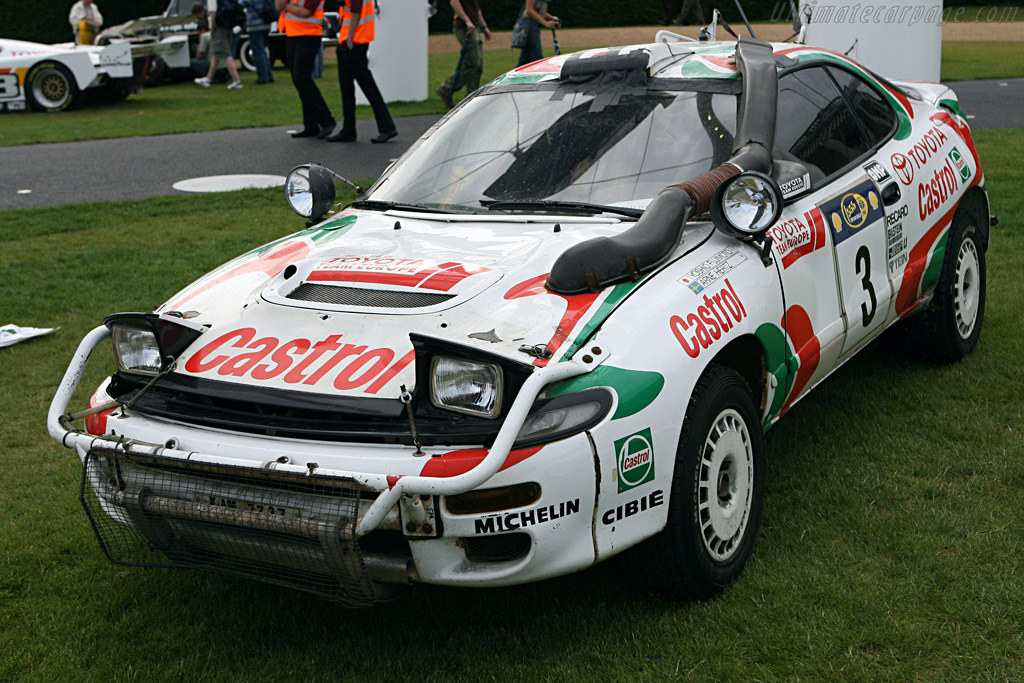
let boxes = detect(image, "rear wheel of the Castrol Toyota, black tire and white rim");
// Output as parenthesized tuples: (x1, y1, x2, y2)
(911, 203, 987, 362)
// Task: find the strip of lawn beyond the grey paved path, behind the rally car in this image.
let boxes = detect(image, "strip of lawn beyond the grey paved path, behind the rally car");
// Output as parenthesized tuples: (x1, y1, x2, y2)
(0, 39, 1024, 146)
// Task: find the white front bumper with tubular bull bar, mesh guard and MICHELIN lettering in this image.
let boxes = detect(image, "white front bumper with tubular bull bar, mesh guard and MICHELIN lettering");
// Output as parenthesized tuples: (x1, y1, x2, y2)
(48, 328, 603, 605)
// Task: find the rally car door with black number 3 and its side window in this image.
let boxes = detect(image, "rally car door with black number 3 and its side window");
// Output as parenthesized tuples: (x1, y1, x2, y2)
(769, 65, 892, 408)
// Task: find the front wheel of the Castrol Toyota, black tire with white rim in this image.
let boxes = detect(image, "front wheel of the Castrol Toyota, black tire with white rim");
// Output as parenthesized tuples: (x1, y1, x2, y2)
(637, 365, 765, 600)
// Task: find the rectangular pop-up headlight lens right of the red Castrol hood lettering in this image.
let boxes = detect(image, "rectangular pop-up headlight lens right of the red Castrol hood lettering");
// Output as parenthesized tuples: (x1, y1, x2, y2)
(430, 355, 502, 418)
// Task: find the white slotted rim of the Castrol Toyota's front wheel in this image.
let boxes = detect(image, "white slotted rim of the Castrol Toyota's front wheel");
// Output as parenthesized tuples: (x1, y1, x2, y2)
(697, 408, 754, 562)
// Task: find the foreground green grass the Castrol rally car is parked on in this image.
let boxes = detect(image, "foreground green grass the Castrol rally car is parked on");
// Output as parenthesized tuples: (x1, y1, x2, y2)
(0, 131, 1024, 682)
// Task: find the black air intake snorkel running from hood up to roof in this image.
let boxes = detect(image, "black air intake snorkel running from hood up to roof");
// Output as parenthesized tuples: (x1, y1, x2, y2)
(545, 36, 778, 294)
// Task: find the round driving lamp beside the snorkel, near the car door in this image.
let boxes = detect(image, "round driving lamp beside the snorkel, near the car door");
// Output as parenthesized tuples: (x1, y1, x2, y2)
(711, 171, 782, 241)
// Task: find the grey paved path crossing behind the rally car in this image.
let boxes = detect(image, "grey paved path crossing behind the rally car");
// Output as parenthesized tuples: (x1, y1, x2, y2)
(0, 79, 1024, 210)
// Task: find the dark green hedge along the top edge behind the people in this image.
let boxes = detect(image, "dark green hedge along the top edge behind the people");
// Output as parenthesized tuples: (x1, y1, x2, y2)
(0, 0, 1019, 43)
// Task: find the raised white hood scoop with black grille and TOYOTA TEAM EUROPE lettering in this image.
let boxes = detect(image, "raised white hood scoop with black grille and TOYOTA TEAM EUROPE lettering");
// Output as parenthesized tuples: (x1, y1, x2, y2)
(263, 255, 502, 314)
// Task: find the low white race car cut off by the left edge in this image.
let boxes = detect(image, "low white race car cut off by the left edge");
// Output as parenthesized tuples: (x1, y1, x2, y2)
(0, 39, 132, 112)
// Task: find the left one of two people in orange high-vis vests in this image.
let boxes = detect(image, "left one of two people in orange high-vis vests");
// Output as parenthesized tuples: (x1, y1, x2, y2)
(275, 0, 335, 139)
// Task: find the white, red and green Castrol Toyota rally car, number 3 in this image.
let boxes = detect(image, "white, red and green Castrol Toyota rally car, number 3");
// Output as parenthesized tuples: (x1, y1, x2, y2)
(48, 34, 989, 604)
